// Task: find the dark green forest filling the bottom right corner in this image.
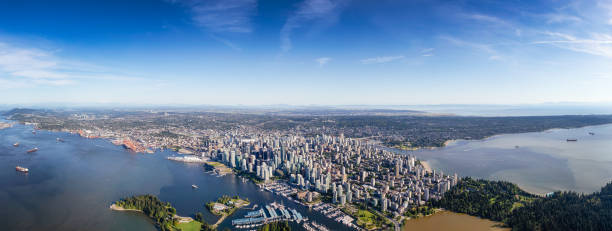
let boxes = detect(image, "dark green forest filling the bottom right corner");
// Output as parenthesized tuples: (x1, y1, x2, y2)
(433, 178, 612, 231)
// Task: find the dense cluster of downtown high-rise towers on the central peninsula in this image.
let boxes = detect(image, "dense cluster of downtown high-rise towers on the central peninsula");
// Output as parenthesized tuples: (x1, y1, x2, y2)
(204, 134, 458, 221)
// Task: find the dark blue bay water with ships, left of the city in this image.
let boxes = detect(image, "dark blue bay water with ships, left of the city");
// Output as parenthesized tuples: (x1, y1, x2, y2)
(0, 122, 346, 230)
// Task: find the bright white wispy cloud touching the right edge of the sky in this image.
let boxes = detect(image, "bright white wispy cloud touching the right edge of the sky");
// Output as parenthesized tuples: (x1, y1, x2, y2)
(533, 32, 612, 58)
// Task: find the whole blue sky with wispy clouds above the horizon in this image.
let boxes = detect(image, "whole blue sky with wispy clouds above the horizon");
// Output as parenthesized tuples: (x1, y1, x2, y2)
(0, 0, 612, 105)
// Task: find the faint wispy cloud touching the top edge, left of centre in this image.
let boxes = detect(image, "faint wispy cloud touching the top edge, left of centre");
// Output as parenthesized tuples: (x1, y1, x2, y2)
(169, 0, 257, 33)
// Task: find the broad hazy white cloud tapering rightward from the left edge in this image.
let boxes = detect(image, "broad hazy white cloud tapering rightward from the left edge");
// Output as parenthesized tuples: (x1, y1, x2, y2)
(0, 42, 142, 88)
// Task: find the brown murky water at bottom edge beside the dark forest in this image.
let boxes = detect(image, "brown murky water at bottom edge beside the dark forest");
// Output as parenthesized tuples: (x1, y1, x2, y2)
(402, 211, 510, 231)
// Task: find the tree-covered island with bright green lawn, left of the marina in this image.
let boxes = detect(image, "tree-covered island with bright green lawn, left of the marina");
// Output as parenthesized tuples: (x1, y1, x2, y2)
(110, 194, 208, 231)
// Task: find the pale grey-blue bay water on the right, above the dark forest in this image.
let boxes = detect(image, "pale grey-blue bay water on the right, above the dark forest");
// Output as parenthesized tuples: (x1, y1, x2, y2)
(396, 124, 612, 194)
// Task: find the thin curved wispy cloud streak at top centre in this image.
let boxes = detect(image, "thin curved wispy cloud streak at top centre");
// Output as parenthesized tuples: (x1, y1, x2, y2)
(280, 0, 346, 52)
